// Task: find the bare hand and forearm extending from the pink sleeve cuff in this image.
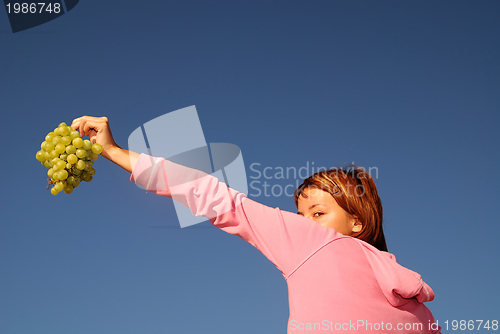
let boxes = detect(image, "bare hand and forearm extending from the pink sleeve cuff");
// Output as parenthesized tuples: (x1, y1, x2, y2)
(71, 116, 139, 173)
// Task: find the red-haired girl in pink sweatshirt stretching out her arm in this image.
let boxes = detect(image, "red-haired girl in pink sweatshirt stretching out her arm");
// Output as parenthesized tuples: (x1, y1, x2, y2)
(72, 116, 440, 333)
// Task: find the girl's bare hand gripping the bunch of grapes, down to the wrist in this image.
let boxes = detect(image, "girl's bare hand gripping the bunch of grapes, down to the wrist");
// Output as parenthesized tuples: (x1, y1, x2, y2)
(71, 116, 118, 157)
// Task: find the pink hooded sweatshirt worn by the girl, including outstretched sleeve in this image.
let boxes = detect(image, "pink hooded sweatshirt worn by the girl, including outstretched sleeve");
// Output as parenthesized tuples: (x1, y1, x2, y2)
(131, 154, 441, 334)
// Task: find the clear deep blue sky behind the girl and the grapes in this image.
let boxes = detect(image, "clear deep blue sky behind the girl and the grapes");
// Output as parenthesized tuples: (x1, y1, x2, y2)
(0, 0, 500, 334)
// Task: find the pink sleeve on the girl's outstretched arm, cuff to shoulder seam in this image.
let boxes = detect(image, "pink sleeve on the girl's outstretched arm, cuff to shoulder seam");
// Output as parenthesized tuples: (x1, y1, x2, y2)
(130, 154, 336, 277)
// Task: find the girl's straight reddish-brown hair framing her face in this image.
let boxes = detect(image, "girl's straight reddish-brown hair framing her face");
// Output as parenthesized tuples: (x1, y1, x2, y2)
(294, 165, 387, 251)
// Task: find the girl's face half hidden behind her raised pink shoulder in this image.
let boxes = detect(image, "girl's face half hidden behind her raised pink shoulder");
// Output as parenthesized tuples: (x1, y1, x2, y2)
(297, 188, 362, 236)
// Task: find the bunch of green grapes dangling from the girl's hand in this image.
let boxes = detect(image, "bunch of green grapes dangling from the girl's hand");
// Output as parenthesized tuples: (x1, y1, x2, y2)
(36, 122, 102, 195)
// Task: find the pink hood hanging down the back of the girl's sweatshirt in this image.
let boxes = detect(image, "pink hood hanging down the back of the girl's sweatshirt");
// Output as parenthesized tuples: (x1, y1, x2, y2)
(362, 242, 434, 307)
